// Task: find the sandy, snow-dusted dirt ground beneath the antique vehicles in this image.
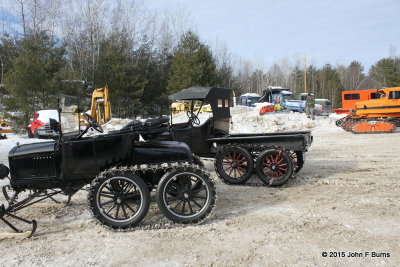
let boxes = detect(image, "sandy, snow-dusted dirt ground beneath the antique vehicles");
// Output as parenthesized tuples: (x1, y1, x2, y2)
(0, 127, 400, 266)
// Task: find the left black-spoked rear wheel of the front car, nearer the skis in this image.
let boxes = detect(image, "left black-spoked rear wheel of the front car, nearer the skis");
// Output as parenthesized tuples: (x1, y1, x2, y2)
(88, 171, 150, 229)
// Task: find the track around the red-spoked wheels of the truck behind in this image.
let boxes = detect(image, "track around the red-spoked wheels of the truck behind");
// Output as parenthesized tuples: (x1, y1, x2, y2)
(214, 144, 296, 187)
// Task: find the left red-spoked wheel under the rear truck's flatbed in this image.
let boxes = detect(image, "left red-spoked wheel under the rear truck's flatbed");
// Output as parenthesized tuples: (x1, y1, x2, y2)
(215, 147, 254, 184)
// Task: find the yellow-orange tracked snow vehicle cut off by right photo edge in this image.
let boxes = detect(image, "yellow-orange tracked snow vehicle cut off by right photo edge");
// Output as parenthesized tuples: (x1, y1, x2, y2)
(340, 87, 400, 134)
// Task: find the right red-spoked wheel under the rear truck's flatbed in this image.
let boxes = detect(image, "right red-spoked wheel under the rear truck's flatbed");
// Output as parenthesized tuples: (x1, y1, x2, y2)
(256, 149, 294, 186)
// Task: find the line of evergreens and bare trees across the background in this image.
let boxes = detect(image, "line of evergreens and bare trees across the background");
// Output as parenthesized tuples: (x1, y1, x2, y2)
(0, 0, 400, 131)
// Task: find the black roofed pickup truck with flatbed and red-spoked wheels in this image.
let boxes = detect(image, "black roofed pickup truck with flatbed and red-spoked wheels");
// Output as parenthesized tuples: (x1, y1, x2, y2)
(164, 87, 312, 186)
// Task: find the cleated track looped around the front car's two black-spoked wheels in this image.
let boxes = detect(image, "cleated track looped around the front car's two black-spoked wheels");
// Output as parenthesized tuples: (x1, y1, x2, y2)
(87, 159, 218, 232)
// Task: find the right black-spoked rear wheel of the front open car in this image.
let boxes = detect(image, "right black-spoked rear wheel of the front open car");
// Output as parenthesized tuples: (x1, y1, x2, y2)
(156, 167, 216, 224)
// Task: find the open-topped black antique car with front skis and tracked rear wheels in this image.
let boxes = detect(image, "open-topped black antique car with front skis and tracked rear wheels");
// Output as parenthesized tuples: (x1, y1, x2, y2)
(0, 95, 216, 238)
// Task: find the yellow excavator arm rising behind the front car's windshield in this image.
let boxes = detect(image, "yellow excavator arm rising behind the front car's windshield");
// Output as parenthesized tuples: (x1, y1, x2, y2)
(90, 86, 112, 125)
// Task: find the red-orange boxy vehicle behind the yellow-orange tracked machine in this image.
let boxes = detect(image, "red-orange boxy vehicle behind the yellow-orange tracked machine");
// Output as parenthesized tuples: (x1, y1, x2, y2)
(334, 89, 379, 114)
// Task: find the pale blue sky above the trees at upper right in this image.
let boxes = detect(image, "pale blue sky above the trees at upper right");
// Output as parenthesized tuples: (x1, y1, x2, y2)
(145, 0, 400, 71)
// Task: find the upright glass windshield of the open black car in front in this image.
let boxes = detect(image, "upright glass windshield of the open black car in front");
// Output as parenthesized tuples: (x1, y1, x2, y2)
(59, 95, 79, 134)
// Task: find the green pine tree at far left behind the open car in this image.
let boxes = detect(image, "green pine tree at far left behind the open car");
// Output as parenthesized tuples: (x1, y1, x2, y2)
(4, 33, 65, 129)
